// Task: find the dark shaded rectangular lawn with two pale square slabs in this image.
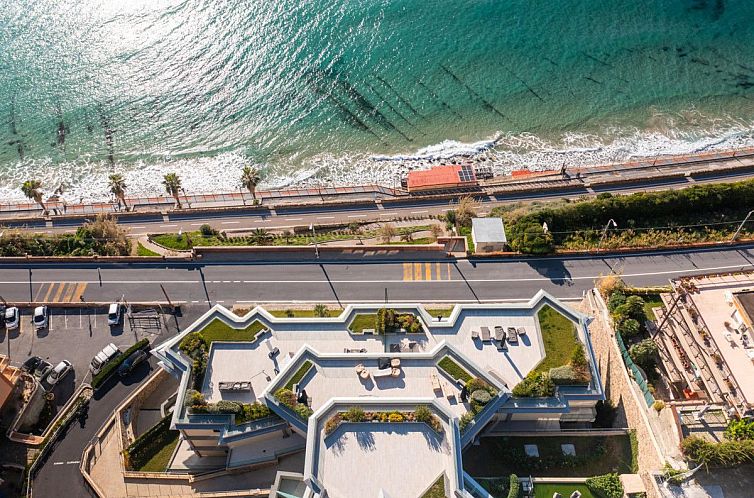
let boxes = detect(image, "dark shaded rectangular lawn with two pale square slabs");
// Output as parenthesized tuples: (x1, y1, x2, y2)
(463, 434, 634, 478)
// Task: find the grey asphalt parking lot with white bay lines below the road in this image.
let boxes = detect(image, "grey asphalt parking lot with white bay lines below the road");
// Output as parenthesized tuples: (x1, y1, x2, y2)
(0, 307, 206, 416)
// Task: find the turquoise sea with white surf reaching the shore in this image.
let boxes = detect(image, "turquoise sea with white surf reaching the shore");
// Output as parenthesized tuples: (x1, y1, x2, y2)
(0, 0, 754, 198)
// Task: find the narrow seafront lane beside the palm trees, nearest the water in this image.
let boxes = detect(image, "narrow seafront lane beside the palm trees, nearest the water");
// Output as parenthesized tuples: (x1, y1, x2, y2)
(11, 162, 754, 236)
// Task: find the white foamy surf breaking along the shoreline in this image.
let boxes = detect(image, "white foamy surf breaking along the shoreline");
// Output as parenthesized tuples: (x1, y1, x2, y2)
(0, 124, 754, 202)
